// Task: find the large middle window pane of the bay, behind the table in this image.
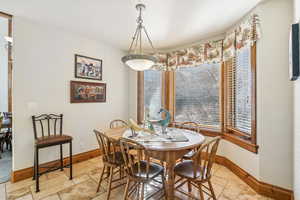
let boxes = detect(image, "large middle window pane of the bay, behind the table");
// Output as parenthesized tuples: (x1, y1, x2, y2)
(175, 64, 220, 127)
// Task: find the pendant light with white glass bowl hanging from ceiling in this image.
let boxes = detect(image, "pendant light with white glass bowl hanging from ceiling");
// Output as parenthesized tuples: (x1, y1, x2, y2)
(122, 4, 157, 71)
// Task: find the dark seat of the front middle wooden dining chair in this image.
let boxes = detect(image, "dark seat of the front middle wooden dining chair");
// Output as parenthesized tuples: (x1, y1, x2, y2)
(133, 161, 164, 179)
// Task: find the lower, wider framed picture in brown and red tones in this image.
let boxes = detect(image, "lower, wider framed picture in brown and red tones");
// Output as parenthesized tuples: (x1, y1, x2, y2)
(70, 81, 106, 103)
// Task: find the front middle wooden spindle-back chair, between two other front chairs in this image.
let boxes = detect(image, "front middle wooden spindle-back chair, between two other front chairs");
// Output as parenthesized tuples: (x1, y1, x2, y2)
(120, 138, 167, 200)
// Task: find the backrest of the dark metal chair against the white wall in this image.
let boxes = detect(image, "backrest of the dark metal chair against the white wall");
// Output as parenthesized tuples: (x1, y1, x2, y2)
(32, 114, 63, 139)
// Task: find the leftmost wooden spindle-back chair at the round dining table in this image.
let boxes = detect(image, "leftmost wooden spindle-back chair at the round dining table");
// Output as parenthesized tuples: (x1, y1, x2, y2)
(94, 130, 125, 200)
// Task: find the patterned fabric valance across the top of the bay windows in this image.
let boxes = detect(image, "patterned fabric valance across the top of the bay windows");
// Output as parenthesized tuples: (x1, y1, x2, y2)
(153, 14, 260, 70)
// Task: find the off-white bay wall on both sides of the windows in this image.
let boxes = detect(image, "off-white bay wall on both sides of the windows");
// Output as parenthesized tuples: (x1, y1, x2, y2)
(129, 0, 292, 189)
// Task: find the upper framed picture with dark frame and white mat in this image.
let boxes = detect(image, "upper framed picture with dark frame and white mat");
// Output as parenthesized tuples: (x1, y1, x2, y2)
(75, 54, 102, 81)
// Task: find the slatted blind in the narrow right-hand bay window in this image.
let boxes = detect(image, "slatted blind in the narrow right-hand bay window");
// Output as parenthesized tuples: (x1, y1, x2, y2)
(225, 46, 252, 134)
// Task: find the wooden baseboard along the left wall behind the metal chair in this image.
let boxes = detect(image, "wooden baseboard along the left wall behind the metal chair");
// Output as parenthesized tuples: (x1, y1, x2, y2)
(11, 149, 100, 183)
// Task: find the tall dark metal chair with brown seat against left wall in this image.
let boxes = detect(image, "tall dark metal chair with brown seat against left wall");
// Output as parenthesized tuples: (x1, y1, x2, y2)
(32, 114, 73, 192)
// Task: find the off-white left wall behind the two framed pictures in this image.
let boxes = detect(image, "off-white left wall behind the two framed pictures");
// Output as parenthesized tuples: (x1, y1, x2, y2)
(13, 16, 128, 170)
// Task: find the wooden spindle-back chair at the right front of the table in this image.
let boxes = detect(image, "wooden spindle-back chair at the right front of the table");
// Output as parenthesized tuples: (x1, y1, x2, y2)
(174, 137, 221, 200)
